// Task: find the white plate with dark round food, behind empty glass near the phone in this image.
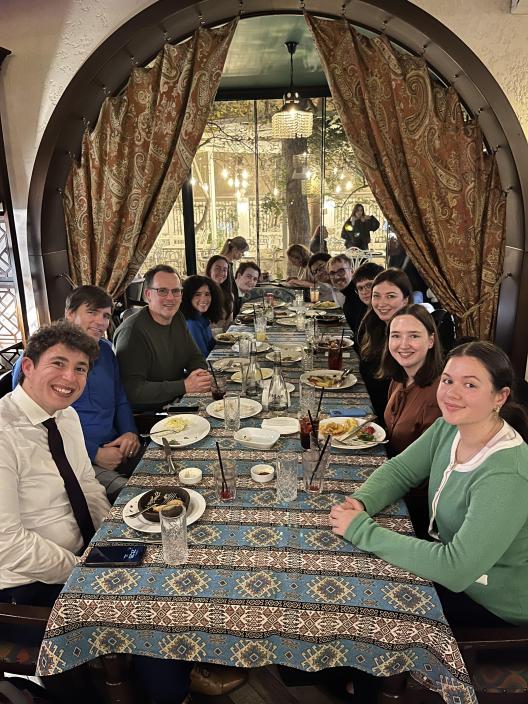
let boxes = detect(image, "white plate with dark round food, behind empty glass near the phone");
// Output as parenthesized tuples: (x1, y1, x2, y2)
(123, 486, 206, 533)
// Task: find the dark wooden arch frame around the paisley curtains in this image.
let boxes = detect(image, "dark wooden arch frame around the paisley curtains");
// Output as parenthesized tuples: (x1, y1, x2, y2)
(28, 0, 528, 372)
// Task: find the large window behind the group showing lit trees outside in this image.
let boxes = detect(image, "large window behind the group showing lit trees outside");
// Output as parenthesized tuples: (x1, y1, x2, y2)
(142, 98, 387, 278)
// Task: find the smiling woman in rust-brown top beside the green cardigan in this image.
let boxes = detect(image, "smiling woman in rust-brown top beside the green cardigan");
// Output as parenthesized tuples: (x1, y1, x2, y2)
(381, 304, 442, 456)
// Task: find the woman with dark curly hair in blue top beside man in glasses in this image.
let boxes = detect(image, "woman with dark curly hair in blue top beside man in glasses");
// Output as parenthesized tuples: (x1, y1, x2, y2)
(180, 276, 223, 357)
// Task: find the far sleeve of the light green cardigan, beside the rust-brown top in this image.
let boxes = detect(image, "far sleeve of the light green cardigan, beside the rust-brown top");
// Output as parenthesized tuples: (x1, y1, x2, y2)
(354, 423, 439, 516)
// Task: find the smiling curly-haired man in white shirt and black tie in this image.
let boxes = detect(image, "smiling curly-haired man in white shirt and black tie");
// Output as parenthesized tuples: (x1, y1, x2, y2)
(0, 322, 110, 605)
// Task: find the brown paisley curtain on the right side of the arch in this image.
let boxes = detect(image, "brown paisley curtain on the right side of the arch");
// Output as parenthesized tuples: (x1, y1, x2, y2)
(305, 14, 506, 339)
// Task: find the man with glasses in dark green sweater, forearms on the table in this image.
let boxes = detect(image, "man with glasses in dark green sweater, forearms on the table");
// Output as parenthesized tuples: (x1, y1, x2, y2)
(113, 264, 211, 411)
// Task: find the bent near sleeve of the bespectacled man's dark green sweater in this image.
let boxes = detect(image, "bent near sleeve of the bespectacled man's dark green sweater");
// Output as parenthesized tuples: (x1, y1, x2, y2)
(114, 316, 187, 408)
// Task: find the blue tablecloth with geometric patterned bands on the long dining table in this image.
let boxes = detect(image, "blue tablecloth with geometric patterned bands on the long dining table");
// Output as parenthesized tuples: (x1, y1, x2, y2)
(38, 326, 476, 704)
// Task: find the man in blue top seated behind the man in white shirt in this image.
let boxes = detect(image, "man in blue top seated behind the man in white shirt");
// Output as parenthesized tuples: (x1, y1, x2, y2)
(13, 286, 140, 501)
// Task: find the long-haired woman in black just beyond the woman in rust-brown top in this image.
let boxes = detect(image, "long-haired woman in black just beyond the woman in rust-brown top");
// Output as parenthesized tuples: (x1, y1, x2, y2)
(356, 269, 412, 419)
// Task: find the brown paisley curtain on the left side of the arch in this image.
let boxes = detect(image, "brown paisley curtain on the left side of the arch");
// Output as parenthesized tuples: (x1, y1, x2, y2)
(64, 19, 237, 296)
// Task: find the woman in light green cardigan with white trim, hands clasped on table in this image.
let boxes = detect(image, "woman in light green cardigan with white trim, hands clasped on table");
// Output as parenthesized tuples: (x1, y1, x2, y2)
(330, 342, 528, 626)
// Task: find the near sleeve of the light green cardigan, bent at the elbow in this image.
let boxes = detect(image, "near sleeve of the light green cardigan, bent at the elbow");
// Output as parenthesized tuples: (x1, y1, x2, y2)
(344, 472, 528, 592)
